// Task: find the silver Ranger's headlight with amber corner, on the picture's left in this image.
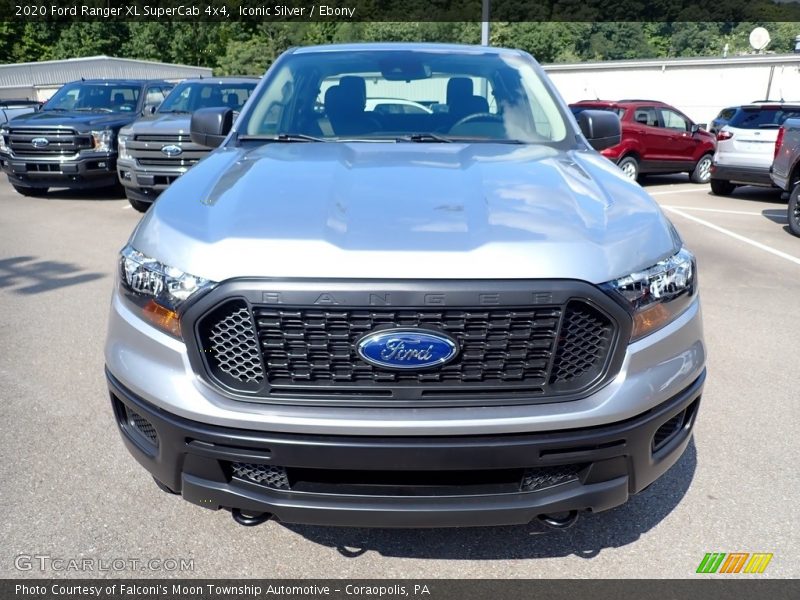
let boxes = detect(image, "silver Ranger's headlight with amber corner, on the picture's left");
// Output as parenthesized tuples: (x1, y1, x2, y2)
(119, 245, 215, 338)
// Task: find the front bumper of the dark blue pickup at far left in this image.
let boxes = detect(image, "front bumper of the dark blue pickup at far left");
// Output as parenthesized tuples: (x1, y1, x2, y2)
(0, 153, 117, 189)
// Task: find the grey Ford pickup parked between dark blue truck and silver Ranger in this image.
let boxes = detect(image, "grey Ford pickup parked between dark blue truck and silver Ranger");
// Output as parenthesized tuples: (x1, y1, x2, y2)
(117, 77, 258, 212)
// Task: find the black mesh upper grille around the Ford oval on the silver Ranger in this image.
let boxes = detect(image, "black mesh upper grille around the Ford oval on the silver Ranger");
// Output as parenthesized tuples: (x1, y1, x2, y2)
(197, 292, 616, 405)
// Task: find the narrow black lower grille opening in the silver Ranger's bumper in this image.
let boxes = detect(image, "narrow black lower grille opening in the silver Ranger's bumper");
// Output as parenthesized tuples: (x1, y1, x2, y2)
(230, 462, 585, 496)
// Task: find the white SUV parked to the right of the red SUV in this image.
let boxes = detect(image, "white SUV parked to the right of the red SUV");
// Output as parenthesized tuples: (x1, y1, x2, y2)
(711, 103, 800, 196)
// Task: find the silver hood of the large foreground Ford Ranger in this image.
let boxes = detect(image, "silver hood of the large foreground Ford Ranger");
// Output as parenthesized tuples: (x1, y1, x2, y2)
(132, 142, 680, 283)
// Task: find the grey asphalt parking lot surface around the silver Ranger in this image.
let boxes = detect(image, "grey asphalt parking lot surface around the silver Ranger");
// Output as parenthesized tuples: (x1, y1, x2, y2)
(0, 176, 800, 578)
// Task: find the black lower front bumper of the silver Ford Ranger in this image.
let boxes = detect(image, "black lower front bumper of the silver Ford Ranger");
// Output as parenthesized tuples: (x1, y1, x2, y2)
(107, 370, 705, 527)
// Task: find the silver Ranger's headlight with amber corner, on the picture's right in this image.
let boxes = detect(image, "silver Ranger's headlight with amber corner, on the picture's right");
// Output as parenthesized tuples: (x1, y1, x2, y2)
(603, 248, 697, 341)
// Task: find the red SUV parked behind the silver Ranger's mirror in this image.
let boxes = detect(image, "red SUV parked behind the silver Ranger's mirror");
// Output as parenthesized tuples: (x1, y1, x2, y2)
(569, 100, 716, 183)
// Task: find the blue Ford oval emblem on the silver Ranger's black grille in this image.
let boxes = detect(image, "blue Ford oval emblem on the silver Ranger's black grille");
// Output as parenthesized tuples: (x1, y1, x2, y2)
(356, 329, 458, 369)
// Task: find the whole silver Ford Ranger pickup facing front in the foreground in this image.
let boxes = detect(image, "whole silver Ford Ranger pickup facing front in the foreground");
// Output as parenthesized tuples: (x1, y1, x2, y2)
(101, 44, 705, 527)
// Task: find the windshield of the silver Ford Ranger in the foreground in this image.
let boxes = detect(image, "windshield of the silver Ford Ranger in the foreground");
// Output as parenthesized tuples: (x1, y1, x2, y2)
(237, 49, 567, 143)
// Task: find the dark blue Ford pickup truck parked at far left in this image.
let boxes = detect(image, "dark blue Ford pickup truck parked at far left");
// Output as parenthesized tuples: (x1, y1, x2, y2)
(0, 79, 173, 196)
